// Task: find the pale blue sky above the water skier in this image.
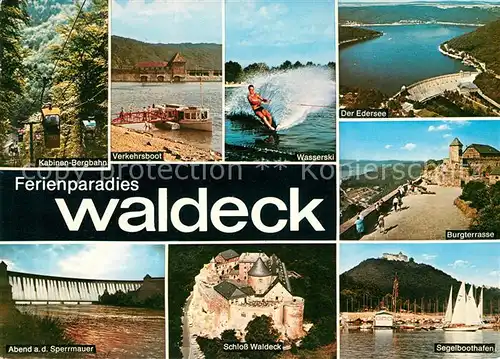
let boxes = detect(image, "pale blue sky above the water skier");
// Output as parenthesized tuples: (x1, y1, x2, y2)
(225, 0, 335, 66)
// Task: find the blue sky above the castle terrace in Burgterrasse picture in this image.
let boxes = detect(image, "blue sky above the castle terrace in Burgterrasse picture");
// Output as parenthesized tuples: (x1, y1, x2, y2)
(339, 120, 500, 161)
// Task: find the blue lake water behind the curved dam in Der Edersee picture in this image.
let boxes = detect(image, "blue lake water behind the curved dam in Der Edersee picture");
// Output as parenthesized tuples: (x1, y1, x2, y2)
(339, 24, 476, 96)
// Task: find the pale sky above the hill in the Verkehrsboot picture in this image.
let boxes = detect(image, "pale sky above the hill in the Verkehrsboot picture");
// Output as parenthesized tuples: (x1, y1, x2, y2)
(111, 0, 222, 44)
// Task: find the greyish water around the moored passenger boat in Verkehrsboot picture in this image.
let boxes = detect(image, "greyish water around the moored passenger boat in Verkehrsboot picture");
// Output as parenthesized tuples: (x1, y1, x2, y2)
(111, 82, 222, 152)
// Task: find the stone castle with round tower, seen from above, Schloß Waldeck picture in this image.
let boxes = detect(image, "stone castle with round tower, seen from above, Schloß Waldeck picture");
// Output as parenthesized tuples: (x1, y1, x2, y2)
(187, 249, 305, 339)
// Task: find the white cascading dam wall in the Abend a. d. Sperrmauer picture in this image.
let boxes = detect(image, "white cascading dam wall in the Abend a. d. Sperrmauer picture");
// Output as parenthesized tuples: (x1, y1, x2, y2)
(7, 271, 143, 304)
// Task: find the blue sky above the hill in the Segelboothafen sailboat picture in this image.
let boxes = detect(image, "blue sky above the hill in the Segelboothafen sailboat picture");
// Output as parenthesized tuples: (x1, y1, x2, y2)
(339, 242, 500, 288)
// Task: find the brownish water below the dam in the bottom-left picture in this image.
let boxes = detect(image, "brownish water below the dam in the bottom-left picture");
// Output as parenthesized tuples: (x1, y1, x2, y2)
(17, 305, 165, 359)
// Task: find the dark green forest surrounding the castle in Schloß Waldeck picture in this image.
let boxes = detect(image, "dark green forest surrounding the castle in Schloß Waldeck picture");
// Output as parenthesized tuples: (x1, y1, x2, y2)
(168, 244, 336, 358)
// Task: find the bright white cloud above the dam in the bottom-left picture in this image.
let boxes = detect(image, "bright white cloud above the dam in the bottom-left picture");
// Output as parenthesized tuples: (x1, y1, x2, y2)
(57, 243, 135, 279)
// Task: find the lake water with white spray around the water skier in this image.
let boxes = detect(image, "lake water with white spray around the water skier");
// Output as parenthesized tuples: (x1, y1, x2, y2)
(225, 67, 336, 161)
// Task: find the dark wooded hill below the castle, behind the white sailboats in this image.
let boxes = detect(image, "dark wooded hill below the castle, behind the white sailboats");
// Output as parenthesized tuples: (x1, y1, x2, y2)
(340, 258, 500, 314)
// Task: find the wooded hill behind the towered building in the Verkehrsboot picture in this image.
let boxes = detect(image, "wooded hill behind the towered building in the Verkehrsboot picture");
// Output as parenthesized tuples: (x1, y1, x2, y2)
(111, 36, 222, 70)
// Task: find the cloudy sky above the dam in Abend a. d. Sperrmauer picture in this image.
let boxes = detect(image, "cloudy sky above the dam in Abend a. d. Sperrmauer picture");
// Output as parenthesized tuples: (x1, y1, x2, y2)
(0, 242, 165, 280)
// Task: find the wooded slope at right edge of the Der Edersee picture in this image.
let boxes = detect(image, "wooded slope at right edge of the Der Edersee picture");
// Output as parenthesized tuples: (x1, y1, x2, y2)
(447, 20, 500, 74)
